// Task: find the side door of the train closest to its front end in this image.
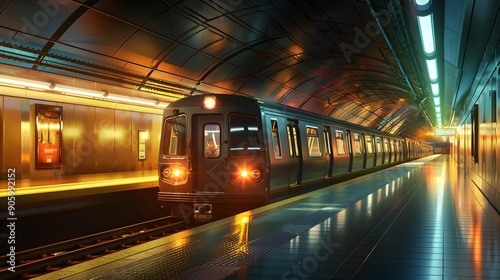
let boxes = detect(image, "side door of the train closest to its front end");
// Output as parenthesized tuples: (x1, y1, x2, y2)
(286, 119, 302, 187)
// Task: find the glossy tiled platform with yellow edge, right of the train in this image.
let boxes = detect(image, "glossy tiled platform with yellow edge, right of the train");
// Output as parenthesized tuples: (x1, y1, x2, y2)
(37, 155, 500, 280)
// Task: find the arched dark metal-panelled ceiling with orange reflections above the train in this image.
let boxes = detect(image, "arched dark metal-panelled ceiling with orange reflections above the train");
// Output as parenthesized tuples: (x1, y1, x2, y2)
(0, 0, 494, 138)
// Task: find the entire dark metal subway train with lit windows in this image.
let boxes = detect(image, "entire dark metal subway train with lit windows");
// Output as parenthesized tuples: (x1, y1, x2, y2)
(158, 95, 432, 221)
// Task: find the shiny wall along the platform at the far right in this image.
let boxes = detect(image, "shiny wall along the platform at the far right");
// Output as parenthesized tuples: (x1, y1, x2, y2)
(452, 55, 500, 214)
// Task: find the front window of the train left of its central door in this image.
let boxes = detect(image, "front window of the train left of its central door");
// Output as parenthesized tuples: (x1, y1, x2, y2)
(161, 116, 186, 156)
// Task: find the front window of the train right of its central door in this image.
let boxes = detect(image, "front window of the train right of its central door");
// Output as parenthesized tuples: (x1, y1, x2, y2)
(229, 114, 260, 156)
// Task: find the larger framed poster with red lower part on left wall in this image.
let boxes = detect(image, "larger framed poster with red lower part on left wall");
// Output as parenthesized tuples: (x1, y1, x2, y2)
(35, 104, 63, 169)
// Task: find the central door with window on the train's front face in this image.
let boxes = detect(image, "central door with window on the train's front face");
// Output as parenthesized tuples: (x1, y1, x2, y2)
(191, 114, 225, 192)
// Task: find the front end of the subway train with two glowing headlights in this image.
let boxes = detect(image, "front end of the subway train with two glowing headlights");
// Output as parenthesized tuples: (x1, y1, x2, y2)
(158, 95, 269, 222)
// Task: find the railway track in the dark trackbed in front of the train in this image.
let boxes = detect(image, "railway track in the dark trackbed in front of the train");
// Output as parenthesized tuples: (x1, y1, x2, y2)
(0, 217, 186, 279)
